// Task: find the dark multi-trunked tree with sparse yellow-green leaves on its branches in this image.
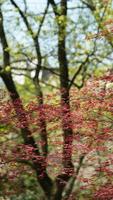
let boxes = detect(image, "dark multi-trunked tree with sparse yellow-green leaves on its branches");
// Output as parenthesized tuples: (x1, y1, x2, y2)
(0, 0, 111, 199)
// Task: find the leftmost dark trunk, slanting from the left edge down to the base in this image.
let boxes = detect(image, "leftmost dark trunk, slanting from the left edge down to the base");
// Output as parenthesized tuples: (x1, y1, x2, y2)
(0, 9, 53, 199)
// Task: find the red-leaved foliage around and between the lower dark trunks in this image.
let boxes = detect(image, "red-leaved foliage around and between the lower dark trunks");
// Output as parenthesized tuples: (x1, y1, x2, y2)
(1, 72, 113, 200)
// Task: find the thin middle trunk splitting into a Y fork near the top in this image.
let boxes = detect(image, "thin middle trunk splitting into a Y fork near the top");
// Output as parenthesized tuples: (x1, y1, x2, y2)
(10, 0, 49, 160)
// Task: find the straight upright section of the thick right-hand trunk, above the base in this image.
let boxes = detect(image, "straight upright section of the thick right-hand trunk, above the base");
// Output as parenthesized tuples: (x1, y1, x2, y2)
(58, 0, 74, 176)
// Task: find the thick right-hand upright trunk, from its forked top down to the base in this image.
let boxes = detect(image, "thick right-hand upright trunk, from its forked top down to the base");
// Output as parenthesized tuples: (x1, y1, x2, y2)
(49, 0, 74, 200)
